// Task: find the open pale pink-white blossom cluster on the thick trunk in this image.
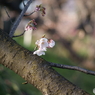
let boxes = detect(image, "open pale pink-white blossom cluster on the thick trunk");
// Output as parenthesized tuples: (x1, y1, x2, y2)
(33, 37, 55, 56)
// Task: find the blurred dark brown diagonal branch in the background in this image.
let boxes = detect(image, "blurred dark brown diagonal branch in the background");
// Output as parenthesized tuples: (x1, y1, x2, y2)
(44, 25, 85, 63)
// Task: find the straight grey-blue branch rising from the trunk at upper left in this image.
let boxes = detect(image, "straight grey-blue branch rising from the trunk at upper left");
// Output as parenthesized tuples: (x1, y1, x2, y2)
(9, 0, 33, 37)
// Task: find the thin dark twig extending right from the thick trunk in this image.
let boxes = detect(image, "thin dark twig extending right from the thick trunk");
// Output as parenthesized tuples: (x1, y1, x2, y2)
(49, 62, 95, 75)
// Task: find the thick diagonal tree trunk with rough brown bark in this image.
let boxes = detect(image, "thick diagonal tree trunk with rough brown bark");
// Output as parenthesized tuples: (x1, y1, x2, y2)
(0, 31, 90, 95)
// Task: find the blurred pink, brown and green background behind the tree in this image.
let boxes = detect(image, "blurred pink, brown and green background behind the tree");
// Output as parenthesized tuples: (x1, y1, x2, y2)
(0, 0, 95, 95)
